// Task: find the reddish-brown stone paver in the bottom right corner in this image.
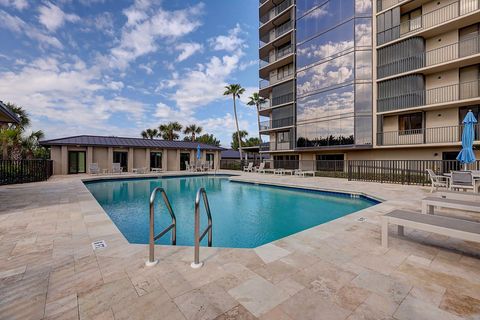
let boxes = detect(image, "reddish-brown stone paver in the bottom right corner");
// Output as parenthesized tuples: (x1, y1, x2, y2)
(440, 290, 480, 319)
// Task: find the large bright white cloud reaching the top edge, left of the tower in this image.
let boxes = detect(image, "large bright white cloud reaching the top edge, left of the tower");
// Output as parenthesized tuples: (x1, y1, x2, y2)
(109, 1, 204, 69)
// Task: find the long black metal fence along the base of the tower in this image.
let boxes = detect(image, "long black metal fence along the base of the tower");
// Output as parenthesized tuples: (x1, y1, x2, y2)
(220, 160, 480, 185)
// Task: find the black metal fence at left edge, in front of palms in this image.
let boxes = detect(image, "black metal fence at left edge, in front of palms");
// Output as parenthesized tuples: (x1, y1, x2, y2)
(0, 160, 53, 185)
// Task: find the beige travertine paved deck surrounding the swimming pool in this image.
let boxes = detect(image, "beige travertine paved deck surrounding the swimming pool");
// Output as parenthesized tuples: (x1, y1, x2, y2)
(0, 173, 480, 320)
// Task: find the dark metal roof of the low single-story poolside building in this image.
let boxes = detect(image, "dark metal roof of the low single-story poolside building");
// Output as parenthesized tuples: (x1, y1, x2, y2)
(40, 135, 225, 150)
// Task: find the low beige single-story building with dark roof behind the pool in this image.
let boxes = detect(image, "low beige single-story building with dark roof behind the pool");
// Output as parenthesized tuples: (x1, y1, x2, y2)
(40, 135, 224, 174)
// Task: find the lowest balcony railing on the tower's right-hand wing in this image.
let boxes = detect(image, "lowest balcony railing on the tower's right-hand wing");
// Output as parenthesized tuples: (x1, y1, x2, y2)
(377, 124, 480, 146)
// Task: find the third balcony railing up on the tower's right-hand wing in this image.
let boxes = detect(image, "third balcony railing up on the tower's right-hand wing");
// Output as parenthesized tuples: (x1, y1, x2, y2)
(377, 36, 480, 78)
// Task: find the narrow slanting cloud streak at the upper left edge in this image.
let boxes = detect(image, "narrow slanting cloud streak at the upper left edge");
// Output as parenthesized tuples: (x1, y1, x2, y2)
(0, 10, 63, 48)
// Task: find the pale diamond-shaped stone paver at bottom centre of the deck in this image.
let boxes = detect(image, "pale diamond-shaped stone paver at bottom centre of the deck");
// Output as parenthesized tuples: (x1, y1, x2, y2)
(228, 277, 289, 317)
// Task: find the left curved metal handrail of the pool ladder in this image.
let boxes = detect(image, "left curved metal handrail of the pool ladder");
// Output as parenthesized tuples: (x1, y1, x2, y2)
(145, 187, 177, 267)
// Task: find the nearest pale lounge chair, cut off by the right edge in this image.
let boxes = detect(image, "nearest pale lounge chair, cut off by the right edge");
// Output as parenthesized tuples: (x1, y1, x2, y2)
(382, 210, 480, 248)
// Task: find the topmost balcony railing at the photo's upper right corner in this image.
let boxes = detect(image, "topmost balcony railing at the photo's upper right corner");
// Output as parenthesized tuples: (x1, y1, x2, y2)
(400, 0, 480, 36)
